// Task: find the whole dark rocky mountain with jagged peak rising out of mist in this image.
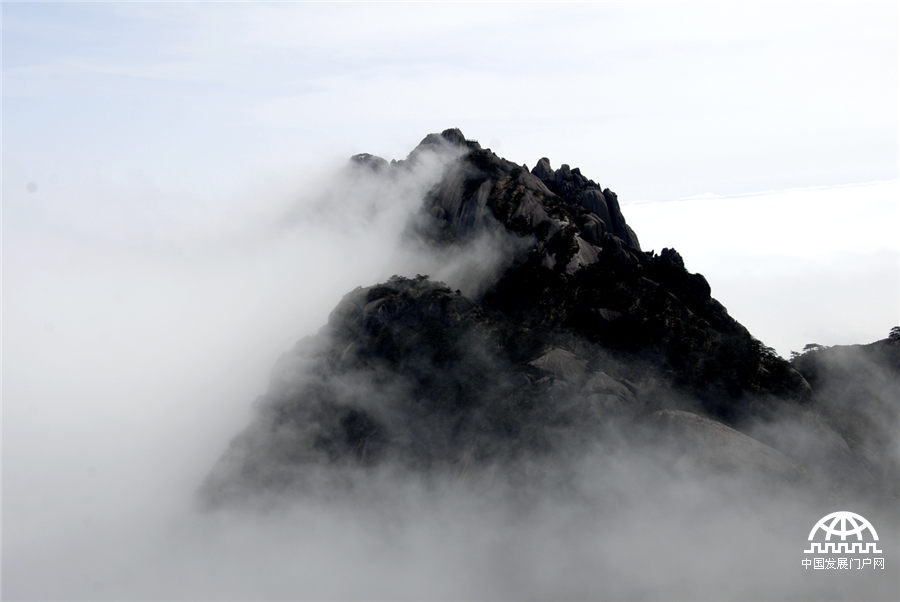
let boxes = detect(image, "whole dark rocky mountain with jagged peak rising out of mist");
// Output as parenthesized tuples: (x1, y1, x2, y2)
(202, 129, 900, 505)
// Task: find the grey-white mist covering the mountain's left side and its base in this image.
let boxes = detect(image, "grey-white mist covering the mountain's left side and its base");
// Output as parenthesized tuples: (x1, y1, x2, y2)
(3, 132, 900, 600)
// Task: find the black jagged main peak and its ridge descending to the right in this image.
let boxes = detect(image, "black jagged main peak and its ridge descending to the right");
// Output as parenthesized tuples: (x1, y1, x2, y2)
(406, 130, 809, 421)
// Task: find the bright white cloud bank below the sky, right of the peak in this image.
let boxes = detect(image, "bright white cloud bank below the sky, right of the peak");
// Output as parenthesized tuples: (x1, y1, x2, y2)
(623, 180, 900, 356)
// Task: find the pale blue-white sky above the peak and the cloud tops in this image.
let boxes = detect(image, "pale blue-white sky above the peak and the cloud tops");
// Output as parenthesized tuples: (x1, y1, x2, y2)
(3, 2, 898, 201)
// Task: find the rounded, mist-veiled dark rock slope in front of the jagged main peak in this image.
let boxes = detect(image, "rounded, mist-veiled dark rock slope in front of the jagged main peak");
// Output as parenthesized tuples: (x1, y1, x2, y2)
(206, 276, 636, 498)
